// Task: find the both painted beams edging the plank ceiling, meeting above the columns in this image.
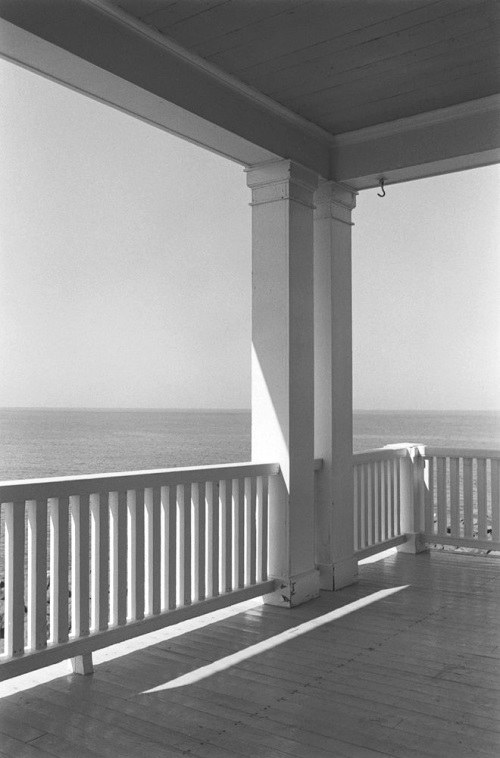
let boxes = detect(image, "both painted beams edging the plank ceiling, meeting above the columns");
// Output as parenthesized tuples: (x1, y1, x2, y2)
(0, 0, 500, 189)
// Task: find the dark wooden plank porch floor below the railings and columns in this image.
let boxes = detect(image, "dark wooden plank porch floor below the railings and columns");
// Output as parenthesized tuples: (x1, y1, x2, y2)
(0, 552, 500, 758)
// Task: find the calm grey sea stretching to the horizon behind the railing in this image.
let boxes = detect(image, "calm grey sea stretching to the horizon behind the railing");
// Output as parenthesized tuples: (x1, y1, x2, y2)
(0, 408, 500, 481)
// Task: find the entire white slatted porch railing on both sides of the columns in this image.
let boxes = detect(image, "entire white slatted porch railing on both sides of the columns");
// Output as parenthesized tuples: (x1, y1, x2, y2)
(0, 445, 500, 679)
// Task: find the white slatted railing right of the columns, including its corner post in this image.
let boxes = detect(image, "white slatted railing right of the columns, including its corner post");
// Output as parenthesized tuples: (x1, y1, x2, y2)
(354, 445, 500, 558)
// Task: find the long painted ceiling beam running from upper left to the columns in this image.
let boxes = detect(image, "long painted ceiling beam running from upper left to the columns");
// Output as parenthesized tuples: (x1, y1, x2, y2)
(0, 0, 331, 178)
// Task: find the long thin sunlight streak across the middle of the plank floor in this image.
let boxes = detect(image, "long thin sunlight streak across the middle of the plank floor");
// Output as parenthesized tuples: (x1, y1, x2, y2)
(142, 584, 410, 695)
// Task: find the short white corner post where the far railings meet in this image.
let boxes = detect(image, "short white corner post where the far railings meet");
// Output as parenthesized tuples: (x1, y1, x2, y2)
(396, 445, 427, 553)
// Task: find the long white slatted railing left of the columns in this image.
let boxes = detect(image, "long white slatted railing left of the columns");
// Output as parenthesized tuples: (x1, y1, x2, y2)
(0, 464, 279, 679)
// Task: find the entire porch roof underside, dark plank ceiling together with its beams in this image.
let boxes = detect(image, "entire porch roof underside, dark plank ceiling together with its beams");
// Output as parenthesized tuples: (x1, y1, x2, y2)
(0, 0, 500, 189)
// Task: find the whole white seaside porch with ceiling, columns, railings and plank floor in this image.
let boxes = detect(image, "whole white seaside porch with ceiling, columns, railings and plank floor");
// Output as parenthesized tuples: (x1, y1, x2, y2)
(0, 0, 500, 758)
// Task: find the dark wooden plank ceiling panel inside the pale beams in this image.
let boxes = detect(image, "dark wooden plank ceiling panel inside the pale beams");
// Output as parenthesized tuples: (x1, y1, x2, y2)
(113, 0, 500, 135)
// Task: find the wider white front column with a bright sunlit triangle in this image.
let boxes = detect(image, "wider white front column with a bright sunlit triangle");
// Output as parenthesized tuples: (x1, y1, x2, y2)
(247, 160, 319, 607)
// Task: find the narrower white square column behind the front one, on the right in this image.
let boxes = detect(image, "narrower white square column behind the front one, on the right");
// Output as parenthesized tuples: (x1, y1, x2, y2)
(314, 181, 358, 590)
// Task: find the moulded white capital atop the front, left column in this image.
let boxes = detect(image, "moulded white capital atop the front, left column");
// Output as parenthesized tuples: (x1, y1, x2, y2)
(245, 160, 318, 208)
